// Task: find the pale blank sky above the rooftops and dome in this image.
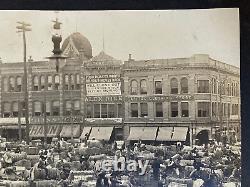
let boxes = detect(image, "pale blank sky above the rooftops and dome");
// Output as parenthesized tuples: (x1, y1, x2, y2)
(0, 8, 240, 67)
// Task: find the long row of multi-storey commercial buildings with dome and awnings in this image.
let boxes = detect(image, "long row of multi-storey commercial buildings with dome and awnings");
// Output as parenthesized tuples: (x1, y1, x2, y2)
(0, 33, 241, 143)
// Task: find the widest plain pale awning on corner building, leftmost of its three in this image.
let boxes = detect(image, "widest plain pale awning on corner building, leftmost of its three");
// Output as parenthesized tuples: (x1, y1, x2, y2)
(127, 127, 158, 140)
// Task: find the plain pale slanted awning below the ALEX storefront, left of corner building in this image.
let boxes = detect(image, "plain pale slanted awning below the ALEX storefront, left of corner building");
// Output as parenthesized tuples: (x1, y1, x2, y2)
(89, 127, 114, 140)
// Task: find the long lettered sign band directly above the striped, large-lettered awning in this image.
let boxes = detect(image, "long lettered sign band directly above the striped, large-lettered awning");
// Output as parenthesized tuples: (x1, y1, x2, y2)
(30, 116, 84, 124)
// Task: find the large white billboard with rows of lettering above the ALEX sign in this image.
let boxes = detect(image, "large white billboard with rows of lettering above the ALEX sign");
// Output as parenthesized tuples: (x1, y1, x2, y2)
(86, 74, 121, 96)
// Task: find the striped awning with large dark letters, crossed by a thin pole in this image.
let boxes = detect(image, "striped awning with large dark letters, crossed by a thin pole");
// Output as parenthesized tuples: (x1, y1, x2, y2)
(29, 125, 61, 137)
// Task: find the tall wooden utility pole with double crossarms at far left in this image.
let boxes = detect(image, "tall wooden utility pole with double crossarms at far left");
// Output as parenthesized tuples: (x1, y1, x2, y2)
(16, 22, 31, 144)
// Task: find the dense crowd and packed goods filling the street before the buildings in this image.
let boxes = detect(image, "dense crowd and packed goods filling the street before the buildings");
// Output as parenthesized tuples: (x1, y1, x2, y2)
(0, 136, 241, 187)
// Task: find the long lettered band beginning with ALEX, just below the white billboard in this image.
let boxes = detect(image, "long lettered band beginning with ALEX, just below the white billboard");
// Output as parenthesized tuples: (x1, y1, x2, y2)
(85, 95, 193, 103)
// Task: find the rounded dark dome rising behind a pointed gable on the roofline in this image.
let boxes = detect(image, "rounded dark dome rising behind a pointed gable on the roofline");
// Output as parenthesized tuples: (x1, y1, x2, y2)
(62, 32, 92, 59)
